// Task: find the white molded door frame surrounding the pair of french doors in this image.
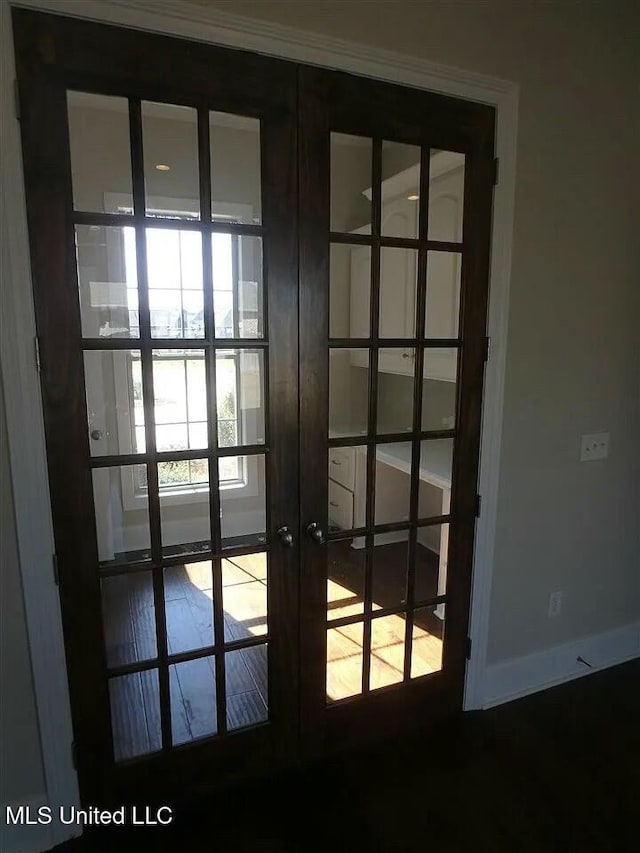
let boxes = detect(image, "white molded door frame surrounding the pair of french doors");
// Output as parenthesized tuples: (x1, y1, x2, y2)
(0, 0, 519, 848)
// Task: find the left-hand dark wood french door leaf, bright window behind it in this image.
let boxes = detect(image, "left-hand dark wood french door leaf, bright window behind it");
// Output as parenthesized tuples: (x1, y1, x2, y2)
(14, 11, 298, 802)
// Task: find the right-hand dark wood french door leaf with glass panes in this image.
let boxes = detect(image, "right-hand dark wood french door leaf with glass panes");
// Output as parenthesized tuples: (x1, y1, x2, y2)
(299, 69, 494, 754)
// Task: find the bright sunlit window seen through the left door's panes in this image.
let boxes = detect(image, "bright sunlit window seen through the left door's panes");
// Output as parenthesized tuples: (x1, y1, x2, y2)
(122, 210, 251, 493)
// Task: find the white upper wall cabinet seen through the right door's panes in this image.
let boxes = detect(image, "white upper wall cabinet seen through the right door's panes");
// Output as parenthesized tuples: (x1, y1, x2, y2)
(349, 152, 464, 382)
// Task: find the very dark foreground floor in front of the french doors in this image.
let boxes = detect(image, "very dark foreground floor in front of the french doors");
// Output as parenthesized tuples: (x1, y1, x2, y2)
(55, 659, 640, 853)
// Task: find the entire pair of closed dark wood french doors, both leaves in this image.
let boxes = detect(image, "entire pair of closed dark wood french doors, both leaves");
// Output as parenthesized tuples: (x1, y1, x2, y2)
(14, 10, 493, 803)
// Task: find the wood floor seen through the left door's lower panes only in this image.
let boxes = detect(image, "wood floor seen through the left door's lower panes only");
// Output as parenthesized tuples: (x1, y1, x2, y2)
(103, 554, 268, 760)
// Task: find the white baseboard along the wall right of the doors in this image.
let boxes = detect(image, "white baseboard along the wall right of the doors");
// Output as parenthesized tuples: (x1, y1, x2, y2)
(482, 622, 640, 708)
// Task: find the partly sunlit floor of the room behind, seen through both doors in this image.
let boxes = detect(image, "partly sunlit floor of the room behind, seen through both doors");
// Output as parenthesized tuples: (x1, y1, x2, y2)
(103, 540, 443, 760)
